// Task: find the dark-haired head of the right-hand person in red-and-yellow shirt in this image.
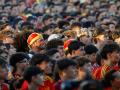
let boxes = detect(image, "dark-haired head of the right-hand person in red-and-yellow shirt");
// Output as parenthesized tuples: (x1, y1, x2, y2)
(100, 43, 120, 64)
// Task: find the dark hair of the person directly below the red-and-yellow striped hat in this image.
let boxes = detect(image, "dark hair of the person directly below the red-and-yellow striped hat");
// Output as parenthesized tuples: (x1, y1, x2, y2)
(30, 54, 50, 66)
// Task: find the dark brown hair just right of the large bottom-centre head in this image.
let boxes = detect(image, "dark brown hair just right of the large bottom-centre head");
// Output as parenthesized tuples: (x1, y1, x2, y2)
(75, 57, 90, 67)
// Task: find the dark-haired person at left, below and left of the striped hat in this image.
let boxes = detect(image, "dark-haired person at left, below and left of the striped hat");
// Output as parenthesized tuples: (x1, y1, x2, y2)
(9, 52, 29, 90)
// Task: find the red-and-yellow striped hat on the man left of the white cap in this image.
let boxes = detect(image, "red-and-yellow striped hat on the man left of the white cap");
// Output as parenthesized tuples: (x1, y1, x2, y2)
(27, 33, 43, 46)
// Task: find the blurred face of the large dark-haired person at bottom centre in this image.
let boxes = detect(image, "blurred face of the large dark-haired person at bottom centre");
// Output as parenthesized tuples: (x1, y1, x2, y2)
(64, 66, 77, 80)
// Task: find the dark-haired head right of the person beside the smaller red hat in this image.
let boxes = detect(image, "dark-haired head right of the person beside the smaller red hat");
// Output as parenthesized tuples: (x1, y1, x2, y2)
(84, 45, 98, 63)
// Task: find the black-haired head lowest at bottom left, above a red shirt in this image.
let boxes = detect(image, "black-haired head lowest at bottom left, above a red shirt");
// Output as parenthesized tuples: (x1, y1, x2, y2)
(24, 66, 44, 86)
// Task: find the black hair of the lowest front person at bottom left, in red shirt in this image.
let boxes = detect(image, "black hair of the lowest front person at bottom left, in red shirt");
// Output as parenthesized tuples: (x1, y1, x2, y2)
(24, 66, 43, 83)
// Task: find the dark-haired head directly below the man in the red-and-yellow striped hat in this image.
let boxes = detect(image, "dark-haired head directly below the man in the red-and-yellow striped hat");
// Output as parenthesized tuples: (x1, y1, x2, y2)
(30, 54, 50, 71)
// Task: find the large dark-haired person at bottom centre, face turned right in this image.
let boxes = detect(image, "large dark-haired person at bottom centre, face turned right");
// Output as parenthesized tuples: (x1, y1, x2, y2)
(54, 58, 77, 90)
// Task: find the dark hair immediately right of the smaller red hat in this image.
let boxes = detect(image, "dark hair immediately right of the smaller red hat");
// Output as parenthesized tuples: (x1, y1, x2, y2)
(68, 40, 85, 54)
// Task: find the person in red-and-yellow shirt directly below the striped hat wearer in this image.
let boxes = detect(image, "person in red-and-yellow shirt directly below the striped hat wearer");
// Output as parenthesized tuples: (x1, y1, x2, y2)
(26, 54, 54, 90)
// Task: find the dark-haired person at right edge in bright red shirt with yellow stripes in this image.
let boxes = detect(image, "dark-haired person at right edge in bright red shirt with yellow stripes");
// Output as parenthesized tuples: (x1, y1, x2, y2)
(93, 43, 119, 80)
